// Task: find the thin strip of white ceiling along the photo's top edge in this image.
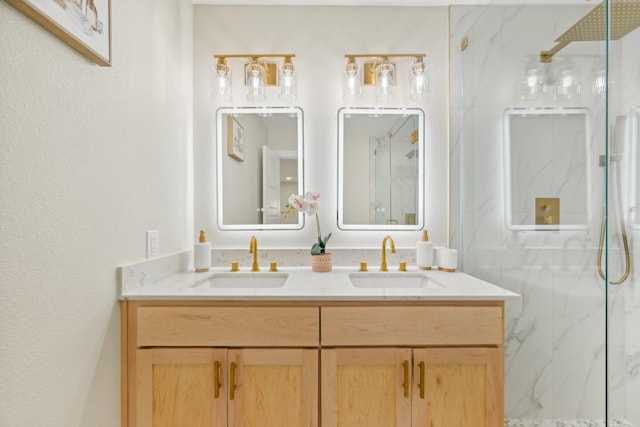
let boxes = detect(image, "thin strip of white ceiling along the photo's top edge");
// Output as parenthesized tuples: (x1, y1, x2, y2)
(192, 0, 600, 6)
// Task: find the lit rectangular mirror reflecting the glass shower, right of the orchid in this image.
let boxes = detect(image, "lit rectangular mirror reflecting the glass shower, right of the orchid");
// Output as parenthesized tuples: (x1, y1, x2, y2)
(338, 108, 424, 230)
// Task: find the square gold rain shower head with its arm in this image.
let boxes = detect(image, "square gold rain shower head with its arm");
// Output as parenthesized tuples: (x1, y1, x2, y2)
(540, 0, 640, 62)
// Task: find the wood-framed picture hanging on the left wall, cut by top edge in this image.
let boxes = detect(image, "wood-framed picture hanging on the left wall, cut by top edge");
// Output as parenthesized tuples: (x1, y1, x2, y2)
(7, 0, 111, 66)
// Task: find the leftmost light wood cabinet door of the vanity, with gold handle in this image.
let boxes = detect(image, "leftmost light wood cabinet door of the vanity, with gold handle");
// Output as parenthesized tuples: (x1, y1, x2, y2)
(134, 348, 227, 427)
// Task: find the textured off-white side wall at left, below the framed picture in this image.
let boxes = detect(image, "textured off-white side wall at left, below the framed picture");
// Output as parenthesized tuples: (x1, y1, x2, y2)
(0, 0, 193, 427)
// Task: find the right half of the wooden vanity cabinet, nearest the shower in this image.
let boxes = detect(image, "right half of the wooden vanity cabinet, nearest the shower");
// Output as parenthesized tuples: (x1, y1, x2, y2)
(321, 303, 504, 427)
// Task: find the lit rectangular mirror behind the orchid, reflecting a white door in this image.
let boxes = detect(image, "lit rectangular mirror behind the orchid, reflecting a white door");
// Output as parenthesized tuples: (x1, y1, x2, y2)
(216, 107, 304, 230)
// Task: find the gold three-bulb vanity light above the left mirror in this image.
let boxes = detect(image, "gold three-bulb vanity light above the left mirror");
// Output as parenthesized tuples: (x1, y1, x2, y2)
(213, 54, 297, 101)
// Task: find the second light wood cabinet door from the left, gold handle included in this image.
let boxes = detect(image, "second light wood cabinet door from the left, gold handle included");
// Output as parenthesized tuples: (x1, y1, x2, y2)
(228, 349, 318, 427)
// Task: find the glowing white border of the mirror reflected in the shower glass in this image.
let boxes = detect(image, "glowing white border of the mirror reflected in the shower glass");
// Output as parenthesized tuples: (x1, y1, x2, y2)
(502, 107, 592, 231)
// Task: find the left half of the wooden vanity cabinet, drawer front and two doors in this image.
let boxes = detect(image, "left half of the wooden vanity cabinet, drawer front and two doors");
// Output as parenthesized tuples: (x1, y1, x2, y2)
(122, 301, 319, 427)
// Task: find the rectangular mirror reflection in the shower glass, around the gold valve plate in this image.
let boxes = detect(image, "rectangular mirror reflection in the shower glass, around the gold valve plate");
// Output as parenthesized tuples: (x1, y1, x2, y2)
(503, 108, 591, 230)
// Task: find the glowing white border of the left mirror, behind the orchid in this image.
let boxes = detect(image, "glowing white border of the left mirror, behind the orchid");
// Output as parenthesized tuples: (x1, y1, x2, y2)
(215, 107, 304, 230)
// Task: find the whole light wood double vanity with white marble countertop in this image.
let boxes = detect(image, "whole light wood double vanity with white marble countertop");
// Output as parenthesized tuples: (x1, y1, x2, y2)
(121, 268, 519, 427)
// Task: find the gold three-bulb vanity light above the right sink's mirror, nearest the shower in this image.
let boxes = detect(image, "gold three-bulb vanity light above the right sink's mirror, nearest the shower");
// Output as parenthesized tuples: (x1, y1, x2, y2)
(342, 53, 429, 101)
